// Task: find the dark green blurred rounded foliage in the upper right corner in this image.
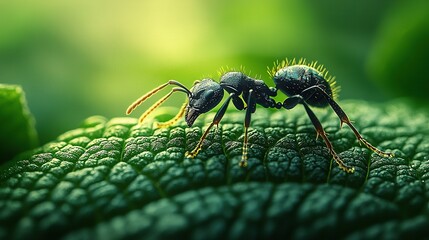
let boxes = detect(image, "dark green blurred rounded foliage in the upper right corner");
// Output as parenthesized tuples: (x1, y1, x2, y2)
(368, 0, 429, 105)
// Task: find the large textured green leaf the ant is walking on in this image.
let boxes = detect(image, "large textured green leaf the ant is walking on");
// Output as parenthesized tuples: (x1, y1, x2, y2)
(0, 102, 429, 239)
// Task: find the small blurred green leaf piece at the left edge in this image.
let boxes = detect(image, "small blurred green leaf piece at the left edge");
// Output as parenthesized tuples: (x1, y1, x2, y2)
(0, 84, 37, 163)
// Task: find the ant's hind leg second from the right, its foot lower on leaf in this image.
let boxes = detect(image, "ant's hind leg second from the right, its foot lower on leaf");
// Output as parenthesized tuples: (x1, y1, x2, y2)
(302, 101, 355, 173)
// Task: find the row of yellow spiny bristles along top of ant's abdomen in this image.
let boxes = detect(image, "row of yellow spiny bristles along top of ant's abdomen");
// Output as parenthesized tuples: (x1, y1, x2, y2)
(268, 58, 340, 100)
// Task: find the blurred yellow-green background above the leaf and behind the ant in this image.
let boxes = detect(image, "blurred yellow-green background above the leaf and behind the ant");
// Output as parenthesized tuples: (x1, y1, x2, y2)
(0, 0, 429, 143)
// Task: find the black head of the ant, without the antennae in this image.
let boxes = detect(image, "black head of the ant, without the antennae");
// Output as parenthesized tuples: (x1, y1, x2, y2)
(185, 78, 223, 126)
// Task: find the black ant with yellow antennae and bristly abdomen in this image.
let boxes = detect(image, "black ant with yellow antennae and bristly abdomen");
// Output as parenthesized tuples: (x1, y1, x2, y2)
(126, 59, 393, 173)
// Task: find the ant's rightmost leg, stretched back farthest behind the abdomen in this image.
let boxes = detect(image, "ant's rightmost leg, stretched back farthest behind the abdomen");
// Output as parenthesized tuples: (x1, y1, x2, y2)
(310, 86, 393, 157)
